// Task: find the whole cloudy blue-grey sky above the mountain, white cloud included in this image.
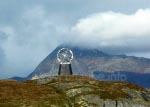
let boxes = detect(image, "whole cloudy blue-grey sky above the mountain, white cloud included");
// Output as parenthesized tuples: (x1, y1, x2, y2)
(0, 0, 150, 79)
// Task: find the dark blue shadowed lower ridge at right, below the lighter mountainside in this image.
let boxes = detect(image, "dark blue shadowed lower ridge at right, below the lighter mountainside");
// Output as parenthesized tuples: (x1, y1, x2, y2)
(94, 71, 150, 88)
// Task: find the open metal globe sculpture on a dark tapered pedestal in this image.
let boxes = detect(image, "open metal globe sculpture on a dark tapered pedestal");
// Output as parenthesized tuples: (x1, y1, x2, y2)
(57, 48, 73, 75)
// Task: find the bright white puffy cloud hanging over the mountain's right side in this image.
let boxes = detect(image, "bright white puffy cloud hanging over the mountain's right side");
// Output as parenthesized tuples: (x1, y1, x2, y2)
(70, 9, 150, 53)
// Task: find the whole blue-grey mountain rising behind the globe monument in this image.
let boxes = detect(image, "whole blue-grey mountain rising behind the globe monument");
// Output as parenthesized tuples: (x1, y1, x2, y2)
(27, 46, 150, 87)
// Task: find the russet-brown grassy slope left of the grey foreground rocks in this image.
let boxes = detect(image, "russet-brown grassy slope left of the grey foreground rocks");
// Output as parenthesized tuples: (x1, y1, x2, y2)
(0, 80, 66, 107)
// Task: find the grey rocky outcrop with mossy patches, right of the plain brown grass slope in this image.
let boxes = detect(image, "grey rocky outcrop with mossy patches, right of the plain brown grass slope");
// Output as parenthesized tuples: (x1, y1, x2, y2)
(34, 76, 150, 107)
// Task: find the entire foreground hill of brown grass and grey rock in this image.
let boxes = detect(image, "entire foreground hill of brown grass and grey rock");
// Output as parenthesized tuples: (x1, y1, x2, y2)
(0, 75, 150, 107)
